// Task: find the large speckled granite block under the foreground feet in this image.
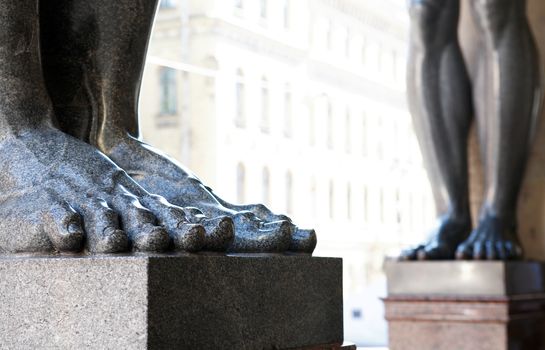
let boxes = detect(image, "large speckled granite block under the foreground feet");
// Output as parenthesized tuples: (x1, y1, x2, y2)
(0, 255, 343, 349)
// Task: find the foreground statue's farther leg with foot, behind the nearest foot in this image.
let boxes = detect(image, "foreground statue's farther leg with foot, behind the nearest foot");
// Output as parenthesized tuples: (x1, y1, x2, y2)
(41, 0, 316, 252)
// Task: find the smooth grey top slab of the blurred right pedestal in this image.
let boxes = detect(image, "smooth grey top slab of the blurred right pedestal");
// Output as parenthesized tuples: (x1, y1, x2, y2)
(385, 260, 545, 296)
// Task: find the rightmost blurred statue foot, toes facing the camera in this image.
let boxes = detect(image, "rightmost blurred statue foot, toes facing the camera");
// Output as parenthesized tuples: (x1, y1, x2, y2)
(456, 214, 522, 260)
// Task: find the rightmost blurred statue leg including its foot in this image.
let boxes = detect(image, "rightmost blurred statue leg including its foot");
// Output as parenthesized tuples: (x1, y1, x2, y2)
(457, 0, 541, 259)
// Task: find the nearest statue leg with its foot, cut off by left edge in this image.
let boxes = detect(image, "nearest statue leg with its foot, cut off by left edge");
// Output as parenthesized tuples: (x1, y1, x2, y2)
(0, 0, 208, 254)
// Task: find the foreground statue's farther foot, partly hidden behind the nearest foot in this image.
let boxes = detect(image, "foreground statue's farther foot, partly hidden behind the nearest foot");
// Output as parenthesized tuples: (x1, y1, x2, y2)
(98, 134, 316, 253)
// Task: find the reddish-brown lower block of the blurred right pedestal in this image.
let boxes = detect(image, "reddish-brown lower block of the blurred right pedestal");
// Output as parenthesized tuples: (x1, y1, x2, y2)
(385, 297, 545, 350)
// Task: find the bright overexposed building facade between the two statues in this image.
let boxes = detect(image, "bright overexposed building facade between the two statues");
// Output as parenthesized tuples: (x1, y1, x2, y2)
(140, 0, 433, 293)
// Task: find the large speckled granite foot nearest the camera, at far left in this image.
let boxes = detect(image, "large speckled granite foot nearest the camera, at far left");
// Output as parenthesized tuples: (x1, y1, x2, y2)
(0, 126, 211, 253)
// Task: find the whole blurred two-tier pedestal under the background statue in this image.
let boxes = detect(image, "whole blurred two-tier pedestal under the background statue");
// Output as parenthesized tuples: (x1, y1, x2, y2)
(384, 261, 545, 350)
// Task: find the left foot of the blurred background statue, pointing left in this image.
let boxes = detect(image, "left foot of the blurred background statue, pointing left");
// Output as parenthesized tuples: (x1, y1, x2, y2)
(399, 216, 471, 260)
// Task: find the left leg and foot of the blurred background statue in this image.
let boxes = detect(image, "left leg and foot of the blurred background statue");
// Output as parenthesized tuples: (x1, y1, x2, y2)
(401, 0, 472, 259)
